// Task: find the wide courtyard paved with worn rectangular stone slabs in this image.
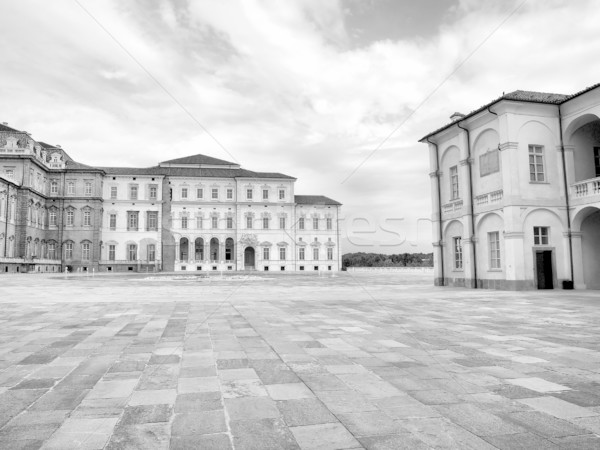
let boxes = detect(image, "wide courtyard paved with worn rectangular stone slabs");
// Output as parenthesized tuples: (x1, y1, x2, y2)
(0, 273, 600, 450)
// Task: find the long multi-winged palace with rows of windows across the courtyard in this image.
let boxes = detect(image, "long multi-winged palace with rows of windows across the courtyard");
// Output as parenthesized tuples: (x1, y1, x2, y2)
(0, 123, 341, 273)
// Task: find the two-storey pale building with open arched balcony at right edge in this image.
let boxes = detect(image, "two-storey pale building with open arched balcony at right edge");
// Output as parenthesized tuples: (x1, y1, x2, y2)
(420, 85, 600, 289)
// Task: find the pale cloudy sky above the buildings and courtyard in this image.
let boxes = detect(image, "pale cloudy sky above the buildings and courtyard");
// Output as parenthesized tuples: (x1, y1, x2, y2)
(0, 0, 600, 253)
